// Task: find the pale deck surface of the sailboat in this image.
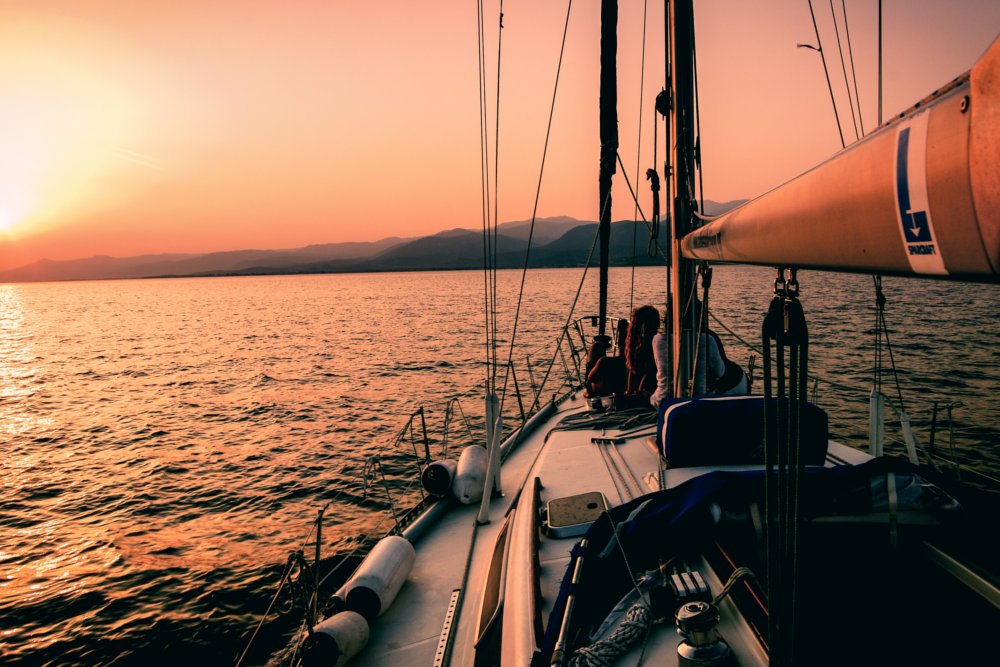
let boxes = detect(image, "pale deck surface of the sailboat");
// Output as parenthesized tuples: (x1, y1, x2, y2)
(351, 397, 869, 665)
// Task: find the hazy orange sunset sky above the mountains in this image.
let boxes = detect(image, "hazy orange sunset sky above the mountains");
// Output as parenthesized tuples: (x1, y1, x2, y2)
(0, 0, 1000, 269)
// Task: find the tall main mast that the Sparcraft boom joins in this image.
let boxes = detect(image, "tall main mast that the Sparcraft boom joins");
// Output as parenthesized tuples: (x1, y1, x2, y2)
(667, 0, 695, 397)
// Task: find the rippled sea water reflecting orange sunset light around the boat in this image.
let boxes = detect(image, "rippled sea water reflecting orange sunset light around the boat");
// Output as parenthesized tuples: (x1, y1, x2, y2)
(0, 267, 1000, 665)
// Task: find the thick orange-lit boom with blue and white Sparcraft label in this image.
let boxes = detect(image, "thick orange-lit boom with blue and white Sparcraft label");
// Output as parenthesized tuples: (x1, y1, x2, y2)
(682, 40, 1000, 282)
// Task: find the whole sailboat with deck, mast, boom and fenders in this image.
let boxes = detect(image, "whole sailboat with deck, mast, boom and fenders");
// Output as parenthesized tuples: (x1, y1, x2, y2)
(246, 0, 1000, 666)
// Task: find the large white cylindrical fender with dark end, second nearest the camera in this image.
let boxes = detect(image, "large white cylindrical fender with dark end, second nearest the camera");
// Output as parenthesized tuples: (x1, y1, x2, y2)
(336, 535, 417, 622)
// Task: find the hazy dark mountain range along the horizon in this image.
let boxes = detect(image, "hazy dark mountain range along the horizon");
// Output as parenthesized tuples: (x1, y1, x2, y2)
(0, 201, 742, 282)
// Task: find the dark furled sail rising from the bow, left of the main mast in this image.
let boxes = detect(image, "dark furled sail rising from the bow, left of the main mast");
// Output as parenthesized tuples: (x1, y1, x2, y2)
(597, 0, 618, 336)
